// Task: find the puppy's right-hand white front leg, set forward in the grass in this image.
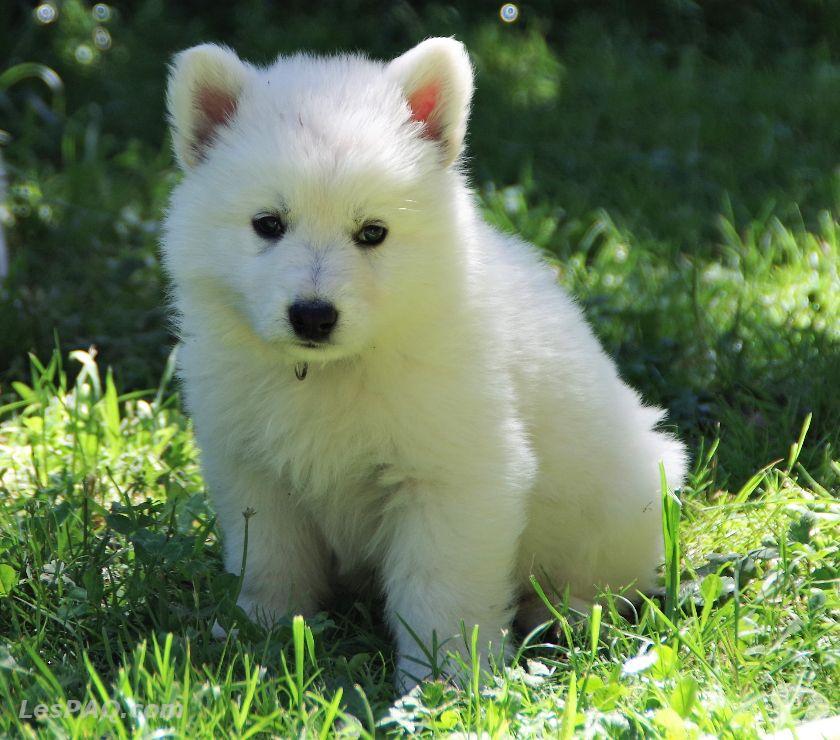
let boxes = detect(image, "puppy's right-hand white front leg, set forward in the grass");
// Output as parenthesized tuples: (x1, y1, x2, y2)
(383, 482, 525, 689)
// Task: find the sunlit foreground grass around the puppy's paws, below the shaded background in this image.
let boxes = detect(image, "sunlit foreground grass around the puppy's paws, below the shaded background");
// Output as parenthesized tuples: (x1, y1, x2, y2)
(0, 352, 840, 737)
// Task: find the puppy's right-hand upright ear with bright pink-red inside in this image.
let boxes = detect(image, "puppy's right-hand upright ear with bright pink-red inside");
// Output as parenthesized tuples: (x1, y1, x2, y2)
(388, 38, 473, 166)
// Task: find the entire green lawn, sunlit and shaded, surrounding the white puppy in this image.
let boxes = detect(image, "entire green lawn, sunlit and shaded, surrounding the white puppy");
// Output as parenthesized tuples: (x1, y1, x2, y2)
(0, 0, 840, 738)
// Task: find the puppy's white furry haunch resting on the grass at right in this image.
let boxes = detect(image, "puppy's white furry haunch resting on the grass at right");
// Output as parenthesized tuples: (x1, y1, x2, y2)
(518, 414, 685, 621)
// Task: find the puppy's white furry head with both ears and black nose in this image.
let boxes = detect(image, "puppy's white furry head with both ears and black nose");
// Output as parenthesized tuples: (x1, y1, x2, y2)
(164, 39, 472, 361)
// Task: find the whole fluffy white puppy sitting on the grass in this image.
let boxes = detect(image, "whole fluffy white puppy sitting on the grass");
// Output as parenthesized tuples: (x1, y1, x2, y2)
(163, 38, 685, 681)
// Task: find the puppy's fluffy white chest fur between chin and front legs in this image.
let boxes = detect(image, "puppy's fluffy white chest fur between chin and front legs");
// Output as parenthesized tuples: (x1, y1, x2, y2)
(206, 358, 418, 570)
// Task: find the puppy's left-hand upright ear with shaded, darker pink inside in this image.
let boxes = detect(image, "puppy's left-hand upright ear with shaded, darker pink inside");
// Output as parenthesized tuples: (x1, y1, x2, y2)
(166, 44, 249, 170)
